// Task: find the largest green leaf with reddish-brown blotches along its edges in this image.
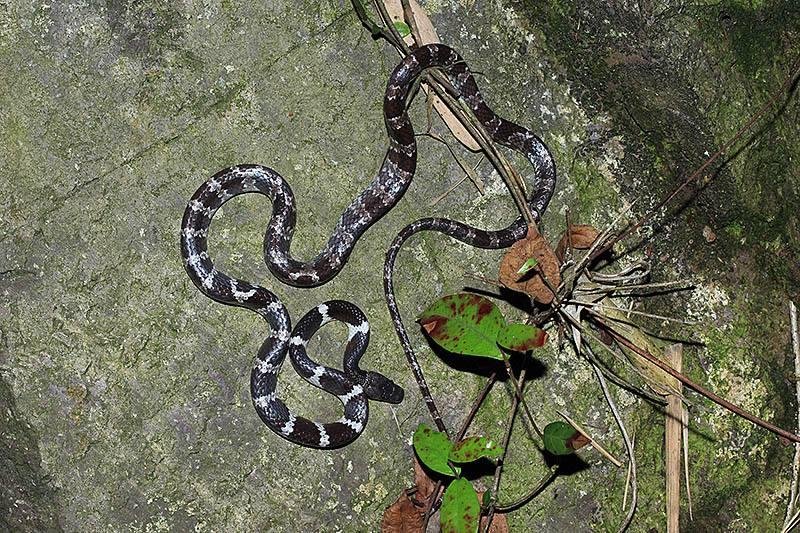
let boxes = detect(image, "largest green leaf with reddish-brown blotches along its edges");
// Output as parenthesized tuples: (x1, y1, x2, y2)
(417, 293, 506, 360)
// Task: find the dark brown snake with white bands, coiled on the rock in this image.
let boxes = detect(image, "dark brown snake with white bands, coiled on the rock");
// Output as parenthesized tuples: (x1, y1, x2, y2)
(180, 44, 556, 449)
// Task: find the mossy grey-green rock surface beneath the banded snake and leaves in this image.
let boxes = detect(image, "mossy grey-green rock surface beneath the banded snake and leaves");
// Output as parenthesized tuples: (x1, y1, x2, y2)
(0, 0, 800, 531)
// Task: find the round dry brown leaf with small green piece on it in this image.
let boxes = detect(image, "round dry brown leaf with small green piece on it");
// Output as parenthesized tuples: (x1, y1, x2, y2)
(499, 224, 561, 304)
